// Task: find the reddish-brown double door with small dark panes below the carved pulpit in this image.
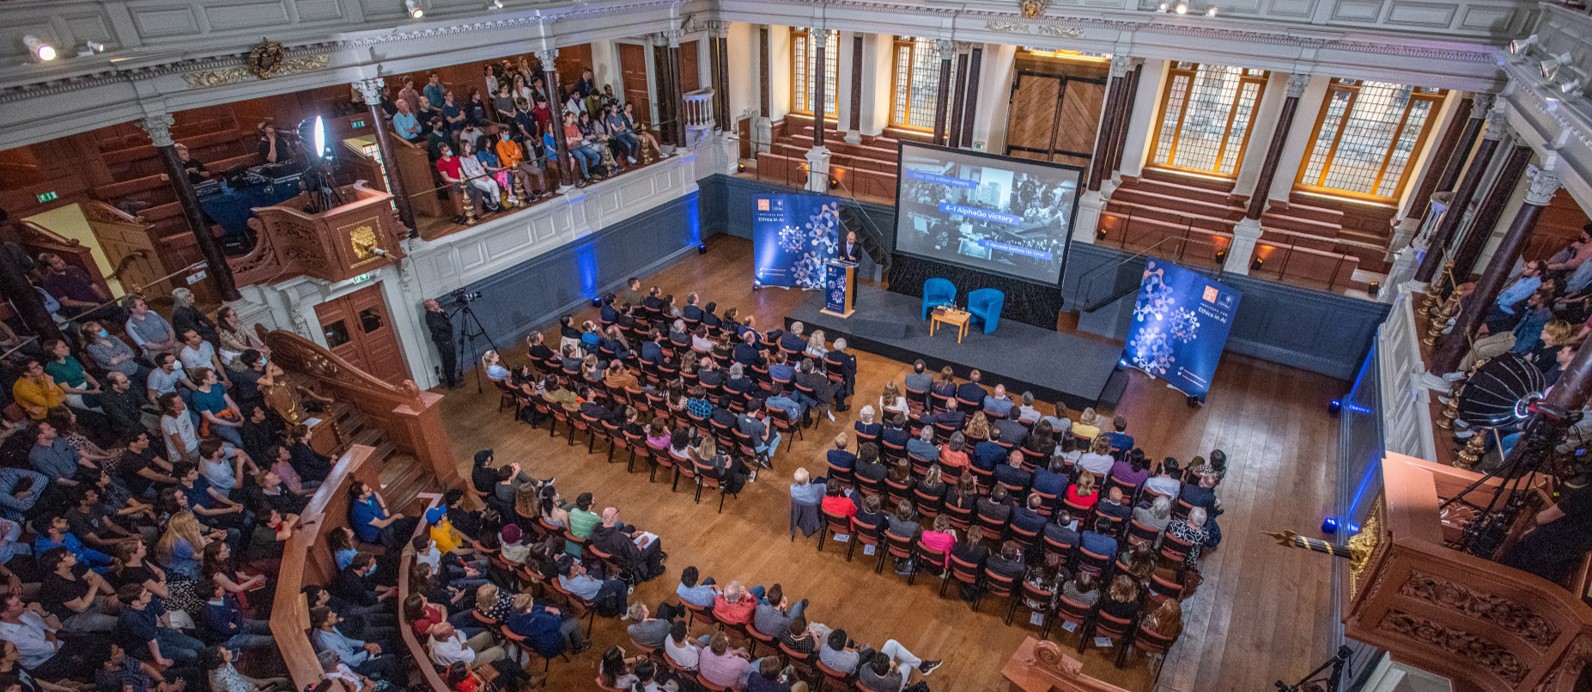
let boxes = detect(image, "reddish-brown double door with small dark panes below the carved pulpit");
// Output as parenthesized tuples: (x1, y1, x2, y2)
(315, 283, 409, 383)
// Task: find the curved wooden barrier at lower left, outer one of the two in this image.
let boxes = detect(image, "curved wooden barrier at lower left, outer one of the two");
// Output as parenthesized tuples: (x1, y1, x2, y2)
(271, 445, 379, 689)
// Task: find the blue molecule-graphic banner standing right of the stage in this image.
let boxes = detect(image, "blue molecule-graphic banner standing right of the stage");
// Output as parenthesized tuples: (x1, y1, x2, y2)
(1122, 259, 1243, 396)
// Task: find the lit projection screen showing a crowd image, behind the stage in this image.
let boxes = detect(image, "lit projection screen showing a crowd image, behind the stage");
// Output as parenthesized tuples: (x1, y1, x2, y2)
(896, 145, 1081, 283)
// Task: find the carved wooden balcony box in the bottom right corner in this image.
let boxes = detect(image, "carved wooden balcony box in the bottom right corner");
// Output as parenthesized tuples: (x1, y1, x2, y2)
(1344, 453, 1592, 692)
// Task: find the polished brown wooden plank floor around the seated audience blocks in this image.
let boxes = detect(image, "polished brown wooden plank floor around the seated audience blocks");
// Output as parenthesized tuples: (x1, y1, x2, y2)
(443, 235, 1345, 692)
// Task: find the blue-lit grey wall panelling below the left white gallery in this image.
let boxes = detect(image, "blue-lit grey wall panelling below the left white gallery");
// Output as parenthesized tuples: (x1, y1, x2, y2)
(454, 194, 708, 358)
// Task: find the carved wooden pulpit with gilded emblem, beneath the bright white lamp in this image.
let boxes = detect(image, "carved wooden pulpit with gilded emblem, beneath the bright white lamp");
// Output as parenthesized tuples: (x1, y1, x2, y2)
(228, 180, 408, 286)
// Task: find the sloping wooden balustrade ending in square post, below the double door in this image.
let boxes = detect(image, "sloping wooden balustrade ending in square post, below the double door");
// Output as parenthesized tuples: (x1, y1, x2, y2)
(255, 325, 463, 487)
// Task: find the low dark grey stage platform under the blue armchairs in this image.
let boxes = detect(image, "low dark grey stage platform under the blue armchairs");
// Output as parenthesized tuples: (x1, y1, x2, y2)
(785, 285, 1127, 410)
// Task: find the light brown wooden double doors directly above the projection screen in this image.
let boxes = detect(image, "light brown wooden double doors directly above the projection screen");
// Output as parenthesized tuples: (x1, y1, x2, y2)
(1006, 68, 1105, 167)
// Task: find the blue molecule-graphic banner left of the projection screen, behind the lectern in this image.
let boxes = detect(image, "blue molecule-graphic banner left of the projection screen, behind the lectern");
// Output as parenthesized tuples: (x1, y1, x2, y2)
(751, 194, 841, 290)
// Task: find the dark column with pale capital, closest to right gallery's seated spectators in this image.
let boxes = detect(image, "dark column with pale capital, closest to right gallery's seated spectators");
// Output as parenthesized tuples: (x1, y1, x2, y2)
(1426, 167, 1560, 378)
